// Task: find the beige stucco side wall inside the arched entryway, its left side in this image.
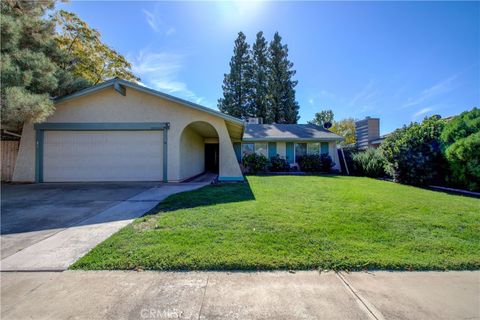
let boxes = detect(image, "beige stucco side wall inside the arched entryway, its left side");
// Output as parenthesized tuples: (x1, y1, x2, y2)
(180, 127, 205, 180)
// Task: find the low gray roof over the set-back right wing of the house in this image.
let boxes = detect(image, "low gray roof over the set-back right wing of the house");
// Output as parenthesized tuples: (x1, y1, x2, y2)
(243, 124, 343, 141)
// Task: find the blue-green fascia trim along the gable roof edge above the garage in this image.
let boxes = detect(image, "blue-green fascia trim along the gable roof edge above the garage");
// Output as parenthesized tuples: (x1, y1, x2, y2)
(54, 78, 245, 126)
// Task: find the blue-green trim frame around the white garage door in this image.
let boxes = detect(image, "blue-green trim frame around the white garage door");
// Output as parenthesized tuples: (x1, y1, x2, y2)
(33, 122, 170, 182)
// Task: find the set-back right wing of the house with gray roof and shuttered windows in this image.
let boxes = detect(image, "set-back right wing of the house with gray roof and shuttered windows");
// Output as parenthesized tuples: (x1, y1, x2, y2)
(238, 123, 343, 170)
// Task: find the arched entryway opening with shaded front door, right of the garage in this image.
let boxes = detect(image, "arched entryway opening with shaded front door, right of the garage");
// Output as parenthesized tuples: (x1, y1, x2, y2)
(179, 121, 220, 180)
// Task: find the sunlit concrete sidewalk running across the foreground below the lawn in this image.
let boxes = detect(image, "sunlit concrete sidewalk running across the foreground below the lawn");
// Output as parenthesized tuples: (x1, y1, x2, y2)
(1, 271, 480, 320)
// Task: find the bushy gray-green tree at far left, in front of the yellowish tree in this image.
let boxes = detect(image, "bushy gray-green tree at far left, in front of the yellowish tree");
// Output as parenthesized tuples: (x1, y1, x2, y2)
(1, 0, 88, 129)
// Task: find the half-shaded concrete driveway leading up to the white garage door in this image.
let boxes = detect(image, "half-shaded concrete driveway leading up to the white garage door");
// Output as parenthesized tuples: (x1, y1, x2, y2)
(0, 182, 208, 271)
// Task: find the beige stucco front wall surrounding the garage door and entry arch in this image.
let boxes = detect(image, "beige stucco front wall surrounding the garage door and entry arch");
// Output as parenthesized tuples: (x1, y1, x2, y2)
(13, 87, 242, 182)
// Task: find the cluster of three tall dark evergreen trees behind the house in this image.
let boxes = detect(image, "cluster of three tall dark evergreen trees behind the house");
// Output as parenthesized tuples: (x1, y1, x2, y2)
(218, 32, 299, 123)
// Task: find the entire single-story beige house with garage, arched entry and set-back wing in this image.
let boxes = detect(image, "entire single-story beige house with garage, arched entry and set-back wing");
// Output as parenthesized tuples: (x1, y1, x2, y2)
(13, 79, 342, 182)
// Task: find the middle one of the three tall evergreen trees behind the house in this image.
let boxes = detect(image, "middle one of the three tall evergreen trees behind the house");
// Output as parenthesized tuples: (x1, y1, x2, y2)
(251, 31, 269, 121)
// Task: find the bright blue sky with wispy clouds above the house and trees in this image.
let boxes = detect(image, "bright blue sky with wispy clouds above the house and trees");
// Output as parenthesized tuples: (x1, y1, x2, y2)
(57, 1, 480, 134)
